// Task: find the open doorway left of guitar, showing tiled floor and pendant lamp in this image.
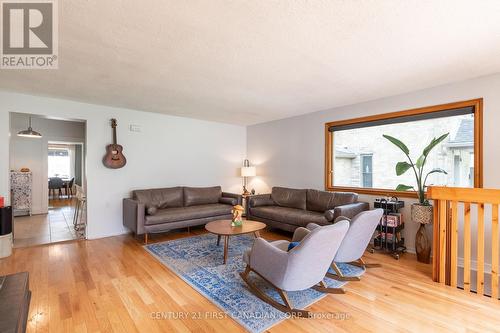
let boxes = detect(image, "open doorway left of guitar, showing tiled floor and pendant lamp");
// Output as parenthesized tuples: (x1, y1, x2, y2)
(10, 113, 86, 247)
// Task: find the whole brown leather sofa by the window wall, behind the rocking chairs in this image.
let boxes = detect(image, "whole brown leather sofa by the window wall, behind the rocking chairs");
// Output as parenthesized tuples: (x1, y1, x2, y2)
(247, 187, 370, 231)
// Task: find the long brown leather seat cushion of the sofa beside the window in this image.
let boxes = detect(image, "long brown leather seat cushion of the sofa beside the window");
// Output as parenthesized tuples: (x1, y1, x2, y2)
(250, 206, 330, 227)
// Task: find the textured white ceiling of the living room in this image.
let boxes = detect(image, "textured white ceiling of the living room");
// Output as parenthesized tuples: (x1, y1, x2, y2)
(0, 0, 500, 124)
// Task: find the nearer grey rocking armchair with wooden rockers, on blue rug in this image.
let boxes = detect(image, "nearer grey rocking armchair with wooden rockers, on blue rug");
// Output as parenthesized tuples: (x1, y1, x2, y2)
(240, 221, 349, 317)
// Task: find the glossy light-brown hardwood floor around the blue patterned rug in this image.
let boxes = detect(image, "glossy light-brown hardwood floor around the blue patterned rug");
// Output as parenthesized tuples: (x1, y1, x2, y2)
(0, 229, 500, 333)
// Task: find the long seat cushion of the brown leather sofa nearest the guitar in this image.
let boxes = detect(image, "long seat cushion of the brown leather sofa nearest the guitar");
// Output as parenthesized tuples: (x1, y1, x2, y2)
(146, 204, 232, 225)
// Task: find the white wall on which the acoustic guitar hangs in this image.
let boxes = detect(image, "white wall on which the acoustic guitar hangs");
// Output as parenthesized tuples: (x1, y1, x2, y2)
(0, 92, 246, 238)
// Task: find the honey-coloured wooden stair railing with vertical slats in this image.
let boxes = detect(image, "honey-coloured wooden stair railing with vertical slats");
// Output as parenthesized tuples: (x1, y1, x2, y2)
(427, 186, 500, 299)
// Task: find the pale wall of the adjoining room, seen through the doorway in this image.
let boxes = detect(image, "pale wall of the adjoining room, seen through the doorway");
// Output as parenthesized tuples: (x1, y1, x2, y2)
(10, 113, 85, 214)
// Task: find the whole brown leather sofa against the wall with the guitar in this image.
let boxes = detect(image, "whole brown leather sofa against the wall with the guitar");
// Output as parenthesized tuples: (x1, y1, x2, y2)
(123, 186, 241, 243)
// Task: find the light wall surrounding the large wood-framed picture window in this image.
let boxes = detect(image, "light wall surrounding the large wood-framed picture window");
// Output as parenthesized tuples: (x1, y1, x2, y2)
(247, 74, 500, 254)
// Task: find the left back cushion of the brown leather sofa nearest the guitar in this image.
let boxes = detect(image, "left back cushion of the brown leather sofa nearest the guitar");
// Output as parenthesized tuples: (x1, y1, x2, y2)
(133, 187, 184, 209)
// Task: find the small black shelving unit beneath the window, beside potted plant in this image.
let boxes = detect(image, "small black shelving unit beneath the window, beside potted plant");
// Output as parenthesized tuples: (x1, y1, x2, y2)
(371, 197, 406, 260)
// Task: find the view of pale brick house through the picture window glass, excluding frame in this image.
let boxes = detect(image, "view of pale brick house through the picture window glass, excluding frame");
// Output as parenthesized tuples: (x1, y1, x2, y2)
(333, 114, 474, 189)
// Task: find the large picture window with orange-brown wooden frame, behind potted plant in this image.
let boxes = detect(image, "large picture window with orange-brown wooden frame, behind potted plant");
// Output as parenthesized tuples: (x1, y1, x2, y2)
(325, 99, 482, 196)
